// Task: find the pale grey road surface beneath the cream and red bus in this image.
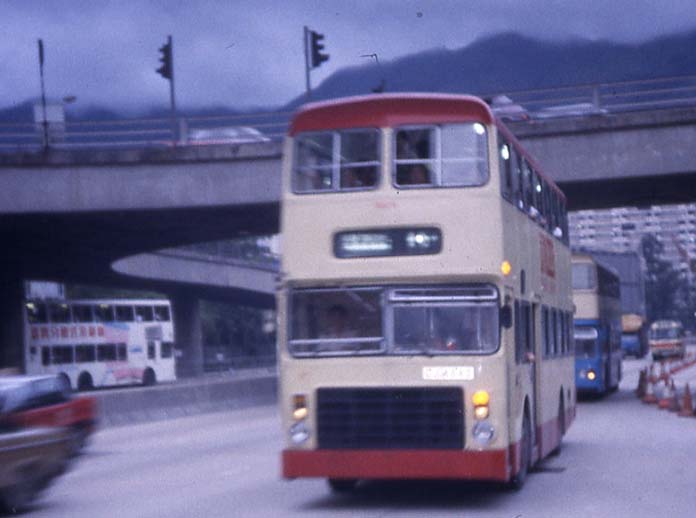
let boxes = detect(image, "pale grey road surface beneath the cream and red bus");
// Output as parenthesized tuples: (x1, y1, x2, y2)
(20, 360, 696, 518)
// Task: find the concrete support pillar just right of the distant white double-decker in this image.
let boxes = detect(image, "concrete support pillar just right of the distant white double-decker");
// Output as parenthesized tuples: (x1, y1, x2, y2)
(172, 292, 203, 378)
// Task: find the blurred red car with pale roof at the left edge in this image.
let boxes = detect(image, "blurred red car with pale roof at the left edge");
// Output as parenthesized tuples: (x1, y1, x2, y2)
(0, 376, 98, 453)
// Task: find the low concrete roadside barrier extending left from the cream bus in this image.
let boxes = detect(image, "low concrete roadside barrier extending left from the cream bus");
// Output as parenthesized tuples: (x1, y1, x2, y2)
(89, 372, 278, 427)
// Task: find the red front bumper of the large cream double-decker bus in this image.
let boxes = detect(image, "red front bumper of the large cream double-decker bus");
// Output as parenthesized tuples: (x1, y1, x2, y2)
(283, 446, 518, 481)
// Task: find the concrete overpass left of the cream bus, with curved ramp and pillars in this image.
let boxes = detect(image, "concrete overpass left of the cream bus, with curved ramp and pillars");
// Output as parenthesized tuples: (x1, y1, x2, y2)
(0, 143, 280, 374)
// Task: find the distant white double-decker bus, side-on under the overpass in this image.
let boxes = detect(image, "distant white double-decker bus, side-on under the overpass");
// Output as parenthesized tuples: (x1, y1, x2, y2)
(24, 299, 176, 390)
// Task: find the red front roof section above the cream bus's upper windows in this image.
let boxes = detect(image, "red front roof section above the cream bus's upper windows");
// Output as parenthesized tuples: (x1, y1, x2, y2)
(290, 93, 495, 136)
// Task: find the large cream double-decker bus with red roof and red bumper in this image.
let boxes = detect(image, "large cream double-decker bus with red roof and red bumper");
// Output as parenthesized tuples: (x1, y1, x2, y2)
(278, 94, 575, 490)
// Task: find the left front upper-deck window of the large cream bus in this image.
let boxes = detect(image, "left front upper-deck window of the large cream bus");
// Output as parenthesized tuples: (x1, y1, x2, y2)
(292, 129, 380, 193)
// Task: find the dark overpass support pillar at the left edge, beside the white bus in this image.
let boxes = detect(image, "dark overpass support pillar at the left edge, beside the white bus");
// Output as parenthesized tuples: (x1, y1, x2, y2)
(0, 279, 24, 372)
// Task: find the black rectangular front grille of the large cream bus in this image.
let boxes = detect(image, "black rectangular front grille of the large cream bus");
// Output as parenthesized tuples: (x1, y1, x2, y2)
(317, 387, 464, 449)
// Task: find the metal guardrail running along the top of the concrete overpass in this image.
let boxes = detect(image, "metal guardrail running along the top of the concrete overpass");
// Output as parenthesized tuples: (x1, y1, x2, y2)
(0, 75, 696, 153)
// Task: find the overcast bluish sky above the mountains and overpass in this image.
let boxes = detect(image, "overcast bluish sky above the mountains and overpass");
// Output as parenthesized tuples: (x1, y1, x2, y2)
(0, 0, 696, 114)
